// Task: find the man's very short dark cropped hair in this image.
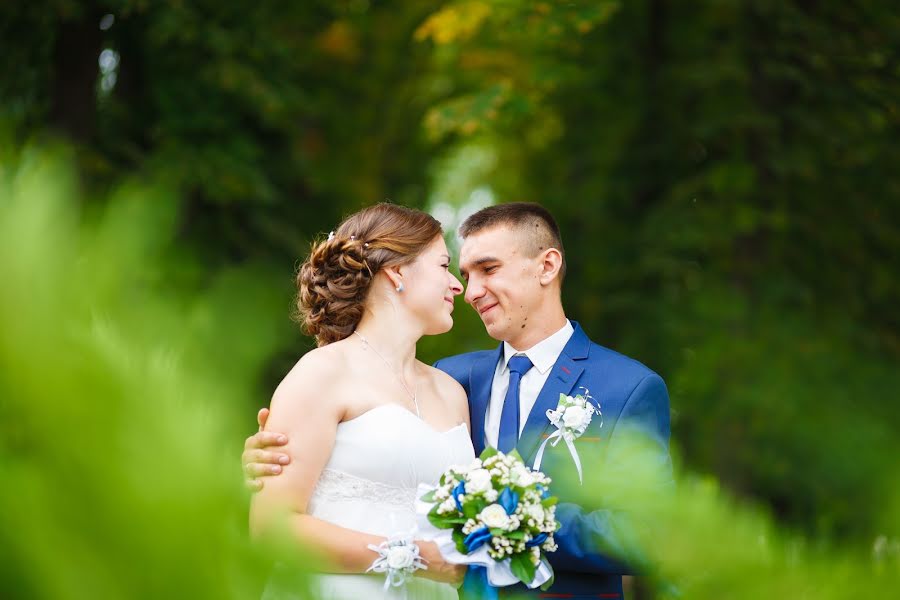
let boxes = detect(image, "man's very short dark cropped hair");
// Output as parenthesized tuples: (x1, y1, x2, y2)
(459, 202, 566, 282)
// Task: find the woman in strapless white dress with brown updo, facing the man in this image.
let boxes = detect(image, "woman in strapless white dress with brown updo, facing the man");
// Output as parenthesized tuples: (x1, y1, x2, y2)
(250, 204, 474, 600)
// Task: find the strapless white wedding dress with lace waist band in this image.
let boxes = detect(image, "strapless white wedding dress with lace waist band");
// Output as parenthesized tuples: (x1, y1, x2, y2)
(263, 404, 475, 600)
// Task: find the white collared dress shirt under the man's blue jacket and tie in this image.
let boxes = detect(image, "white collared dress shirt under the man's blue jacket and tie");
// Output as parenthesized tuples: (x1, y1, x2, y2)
(484, 319, 575, 448)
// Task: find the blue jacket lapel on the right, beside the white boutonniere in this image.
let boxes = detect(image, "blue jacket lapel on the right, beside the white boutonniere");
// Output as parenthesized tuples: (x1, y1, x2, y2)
(516, 321, 590, 465)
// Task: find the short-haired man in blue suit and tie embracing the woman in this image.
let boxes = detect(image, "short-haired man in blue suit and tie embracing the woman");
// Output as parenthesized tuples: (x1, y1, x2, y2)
(244, 202, 670, 598)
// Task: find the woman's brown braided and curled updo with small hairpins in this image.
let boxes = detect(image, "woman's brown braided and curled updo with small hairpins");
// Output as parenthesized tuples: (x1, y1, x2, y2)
(297, 203, 442, 346)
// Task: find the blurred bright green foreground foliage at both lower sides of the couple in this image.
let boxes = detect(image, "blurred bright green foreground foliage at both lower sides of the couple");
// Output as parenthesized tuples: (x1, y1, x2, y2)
(0, 148, 900, 599)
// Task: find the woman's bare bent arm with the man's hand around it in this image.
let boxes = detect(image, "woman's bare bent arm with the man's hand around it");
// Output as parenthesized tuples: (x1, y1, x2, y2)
(250, 351, 384, 573)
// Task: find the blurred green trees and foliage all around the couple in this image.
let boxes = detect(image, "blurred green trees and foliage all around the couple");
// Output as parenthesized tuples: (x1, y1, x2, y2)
(0, 0, 900, 598)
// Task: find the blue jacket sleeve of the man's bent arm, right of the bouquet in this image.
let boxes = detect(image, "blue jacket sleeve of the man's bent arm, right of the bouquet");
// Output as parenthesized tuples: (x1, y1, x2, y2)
(549, 374, 672, 574)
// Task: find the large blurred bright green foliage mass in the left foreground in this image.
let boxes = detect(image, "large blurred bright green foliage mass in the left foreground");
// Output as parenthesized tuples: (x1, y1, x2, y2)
(0, 150, 306, 599)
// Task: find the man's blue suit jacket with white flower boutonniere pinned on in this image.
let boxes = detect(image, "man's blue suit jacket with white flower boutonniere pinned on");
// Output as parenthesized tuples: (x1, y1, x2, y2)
(435, 321, 670, 598)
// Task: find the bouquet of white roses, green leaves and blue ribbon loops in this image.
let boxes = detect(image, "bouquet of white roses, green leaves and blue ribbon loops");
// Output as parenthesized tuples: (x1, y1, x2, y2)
(416, 448, 559, 589)
